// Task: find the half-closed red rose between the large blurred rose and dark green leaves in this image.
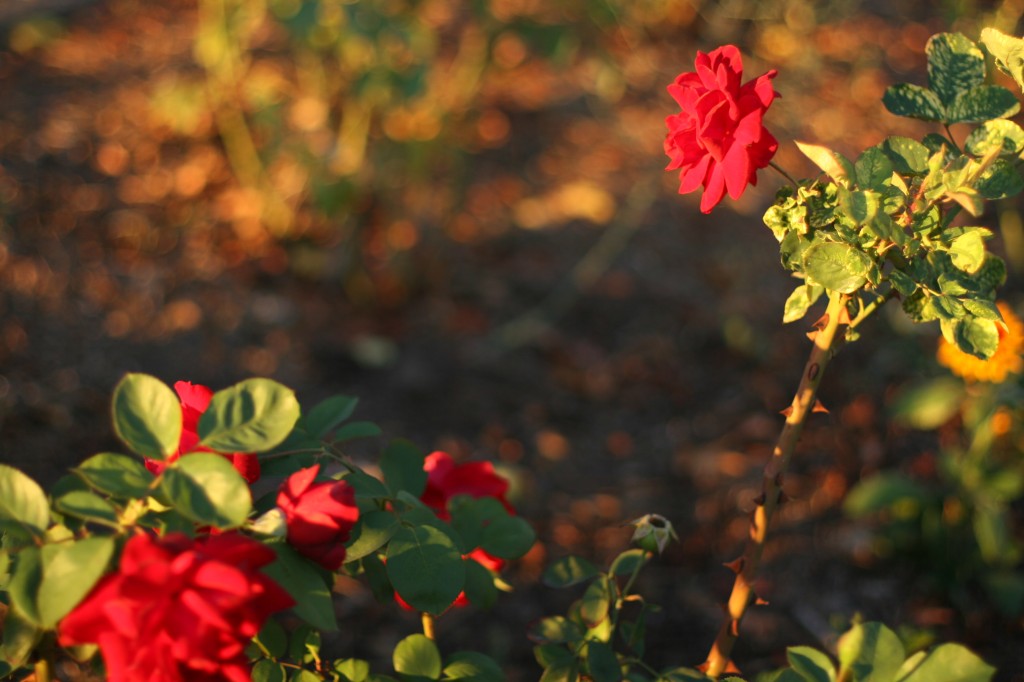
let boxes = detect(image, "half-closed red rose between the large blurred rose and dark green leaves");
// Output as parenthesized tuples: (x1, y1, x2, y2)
(278, 464, 359, 570)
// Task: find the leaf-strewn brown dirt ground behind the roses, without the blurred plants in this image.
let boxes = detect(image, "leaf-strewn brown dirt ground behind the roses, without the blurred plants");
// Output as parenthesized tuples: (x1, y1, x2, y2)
(0, 0, 1024, 680)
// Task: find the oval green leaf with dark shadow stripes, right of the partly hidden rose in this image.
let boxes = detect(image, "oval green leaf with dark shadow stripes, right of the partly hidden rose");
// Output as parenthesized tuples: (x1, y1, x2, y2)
(199, 379, 299, 453)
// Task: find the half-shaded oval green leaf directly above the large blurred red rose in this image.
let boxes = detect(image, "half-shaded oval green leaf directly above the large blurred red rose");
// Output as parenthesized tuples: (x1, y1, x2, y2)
(160, 453, 253, 530)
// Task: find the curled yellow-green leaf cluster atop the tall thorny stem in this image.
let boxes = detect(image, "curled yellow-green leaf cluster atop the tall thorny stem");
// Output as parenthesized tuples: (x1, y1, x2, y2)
(764, 34, 1024, 358)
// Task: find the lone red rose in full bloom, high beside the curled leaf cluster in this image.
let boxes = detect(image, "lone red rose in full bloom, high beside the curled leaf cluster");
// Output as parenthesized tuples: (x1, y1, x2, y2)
(665, 45, 778, 213)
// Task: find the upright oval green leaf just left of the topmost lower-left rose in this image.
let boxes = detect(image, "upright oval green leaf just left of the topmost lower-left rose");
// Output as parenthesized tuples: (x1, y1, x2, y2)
(113, 374, 181, 460)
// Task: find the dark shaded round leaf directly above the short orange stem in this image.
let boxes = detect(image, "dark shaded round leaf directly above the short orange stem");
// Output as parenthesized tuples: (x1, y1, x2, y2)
(386, 525, 466, 615)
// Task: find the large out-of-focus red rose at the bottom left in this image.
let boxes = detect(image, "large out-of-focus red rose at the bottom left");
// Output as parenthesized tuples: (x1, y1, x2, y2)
(57, 532, 294, 682)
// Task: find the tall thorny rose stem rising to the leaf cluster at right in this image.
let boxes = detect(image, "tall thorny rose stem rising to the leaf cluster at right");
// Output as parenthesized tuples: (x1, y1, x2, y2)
(702, 294, 849, 677)
